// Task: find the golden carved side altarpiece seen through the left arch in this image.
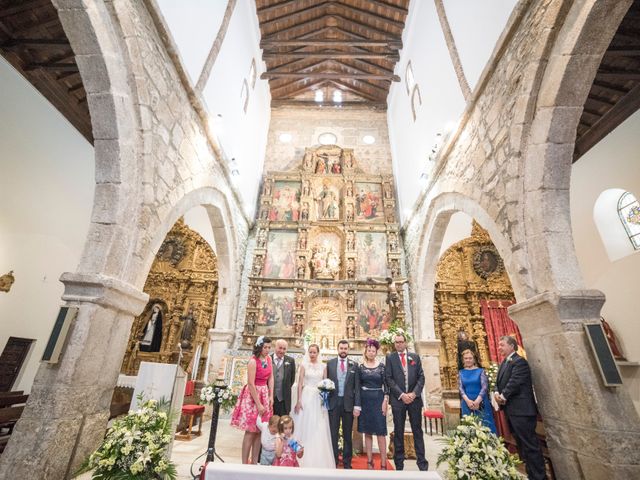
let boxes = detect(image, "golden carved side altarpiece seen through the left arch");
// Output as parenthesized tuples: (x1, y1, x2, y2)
(121, 219, 218, 379)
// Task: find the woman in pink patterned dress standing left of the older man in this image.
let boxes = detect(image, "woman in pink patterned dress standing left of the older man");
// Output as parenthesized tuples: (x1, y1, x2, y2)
(231, 336, 273, 464)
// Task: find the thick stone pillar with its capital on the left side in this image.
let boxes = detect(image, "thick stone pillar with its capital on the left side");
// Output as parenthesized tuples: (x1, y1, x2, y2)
(0, 273, 148, 479)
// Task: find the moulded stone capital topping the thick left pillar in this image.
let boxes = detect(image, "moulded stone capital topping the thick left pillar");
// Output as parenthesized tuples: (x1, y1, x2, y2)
(60, 272, 149, 316)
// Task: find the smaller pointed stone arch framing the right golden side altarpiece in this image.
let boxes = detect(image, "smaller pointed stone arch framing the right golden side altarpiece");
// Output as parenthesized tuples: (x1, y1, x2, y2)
(411, 192, 530, 340)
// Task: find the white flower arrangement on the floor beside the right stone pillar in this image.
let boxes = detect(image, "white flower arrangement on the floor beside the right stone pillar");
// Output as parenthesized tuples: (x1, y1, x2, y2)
(438, 415, 521, 480)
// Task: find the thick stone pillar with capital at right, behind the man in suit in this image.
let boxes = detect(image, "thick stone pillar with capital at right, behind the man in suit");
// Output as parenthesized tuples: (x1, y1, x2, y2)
(509, 290, 640, 480)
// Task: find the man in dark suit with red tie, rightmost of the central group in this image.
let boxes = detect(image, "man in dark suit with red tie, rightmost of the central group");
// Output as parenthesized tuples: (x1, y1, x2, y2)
(384, 335, 429, 470)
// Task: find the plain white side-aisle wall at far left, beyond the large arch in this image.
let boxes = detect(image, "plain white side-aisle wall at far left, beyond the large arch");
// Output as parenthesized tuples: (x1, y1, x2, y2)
(0, 58, 95, 391)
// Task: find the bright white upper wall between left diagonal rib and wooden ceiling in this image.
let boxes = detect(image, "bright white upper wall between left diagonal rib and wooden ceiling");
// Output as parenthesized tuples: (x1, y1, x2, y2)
(203, 0, 271, 216)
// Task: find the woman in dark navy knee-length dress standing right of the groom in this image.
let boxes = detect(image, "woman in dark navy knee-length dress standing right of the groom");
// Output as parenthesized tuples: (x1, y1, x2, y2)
(358, 339, 389, 470)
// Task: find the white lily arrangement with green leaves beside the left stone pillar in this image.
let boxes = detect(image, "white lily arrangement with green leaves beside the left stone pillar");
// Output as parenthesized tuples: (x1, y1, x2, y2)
(80, 396, 178, 480)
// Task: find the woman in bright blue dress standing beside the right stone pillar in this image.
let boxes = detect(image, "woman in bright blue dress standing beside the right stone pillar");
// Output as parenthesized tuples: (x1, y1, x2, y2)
(458, 350, 496, 433)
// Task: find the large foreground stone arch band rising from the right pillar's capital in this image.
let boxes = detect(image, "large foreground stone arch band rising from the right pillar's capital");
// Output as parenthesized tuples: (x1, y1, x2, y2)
(523, 0, 632, 292)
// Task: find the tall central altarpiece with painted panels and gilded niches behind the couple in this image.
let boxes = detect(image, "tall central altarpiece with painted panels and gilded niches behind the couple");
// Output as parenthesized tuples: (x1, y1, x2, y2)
(243, 145, 405, 351)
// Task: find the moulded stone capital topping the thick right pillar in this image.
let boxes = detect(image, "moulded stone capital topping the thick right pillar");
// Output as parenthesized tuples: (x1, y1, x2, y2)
(509, 290, 605, 335)
